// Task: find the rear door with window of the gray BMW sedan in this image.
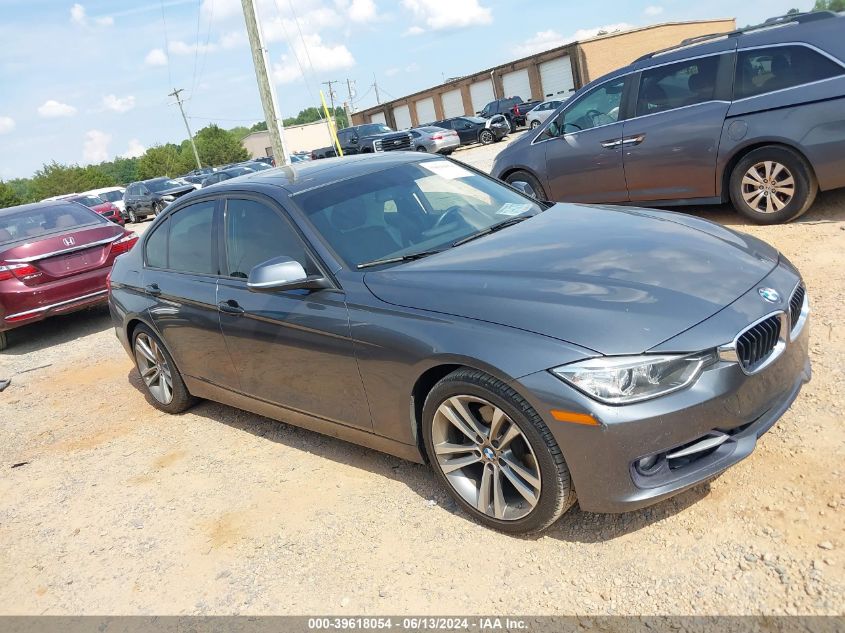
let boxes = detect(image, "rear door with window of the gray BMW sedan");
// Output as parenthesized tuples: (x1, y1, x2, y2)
(142, 198, 239, 389)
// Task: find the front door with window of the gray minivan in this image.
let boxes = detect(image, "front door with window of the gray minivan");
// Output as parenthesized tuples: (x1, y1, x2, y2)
(535, 77, 628, 202)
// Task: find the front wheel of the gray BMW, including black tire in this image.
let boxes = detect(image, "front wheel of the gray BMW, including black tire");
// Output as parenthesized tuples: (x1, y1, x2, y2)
(423, 369, 575, 533)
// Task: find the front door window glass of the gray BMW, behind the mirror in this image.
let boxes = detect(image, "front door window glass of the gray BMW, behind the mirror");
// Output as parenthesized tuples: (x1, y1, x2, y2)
(226, 199, 317, 279)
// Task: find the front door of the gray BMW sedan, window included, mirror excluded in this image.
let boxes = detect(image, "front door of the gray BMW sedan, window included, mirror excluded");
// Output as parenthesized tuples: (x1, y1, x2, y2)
(217, 198, 372, 430)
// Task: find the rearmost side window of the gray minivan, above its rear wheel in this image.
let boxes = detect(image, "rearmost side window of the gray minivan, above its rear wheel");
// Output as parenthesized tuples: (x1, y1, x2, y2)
(734, 46, 845, 99)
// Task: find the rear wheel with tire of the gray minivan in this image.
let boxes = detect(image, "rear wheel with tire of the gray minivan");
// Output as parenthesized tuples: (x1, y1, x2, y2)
(730, 147, 818, 224)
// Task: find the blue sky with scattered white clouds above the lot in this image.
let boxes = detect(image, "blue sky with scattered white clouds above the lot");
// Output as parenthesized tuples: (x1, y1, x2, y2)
(0, 0, 812, 179)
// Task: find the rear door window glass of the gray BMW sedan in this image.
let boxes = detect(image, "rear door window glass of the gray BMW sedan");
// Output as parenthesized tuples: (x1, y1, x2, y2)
(162, 200, 217, 275)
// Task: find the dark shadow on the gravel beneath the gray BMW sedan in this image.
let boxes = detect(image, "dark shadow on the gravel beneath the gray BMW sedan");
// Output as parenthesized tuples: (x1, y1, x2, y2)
(128, 370, 710, 543)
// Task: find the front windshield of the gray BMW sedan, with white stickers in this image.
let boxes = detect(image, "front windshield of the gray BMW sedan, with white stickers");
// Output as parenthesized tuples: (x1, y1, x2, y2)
(294, 159, 542, 268)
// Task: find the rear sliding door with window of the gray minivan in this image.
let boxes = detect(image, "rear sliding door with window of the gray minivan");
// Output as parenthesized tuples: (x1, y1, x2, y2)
(622, 53, 734, 201)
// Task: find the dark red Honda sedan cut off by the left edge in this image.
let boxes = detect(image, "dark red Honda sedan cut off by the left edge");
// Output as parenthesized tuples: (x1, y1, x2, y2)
(0, 200, 138, 349)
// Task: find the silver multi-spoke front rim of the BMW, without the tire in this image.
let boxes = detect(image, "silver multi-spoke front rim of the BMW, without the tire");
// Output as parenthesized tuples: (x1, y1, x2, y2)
(431, 395, 541, 521)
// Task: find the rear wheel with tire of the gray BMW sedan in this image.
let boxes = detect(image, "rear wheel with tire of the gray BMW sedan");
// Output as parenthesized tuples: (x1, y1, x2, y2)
(132, 325, 195, 413)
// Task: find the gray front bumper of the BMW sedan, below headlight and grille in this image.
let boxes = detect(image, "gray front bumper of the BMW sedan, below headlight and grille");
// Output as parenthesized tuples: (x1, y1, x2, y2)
(514, 298, 811, 512)
